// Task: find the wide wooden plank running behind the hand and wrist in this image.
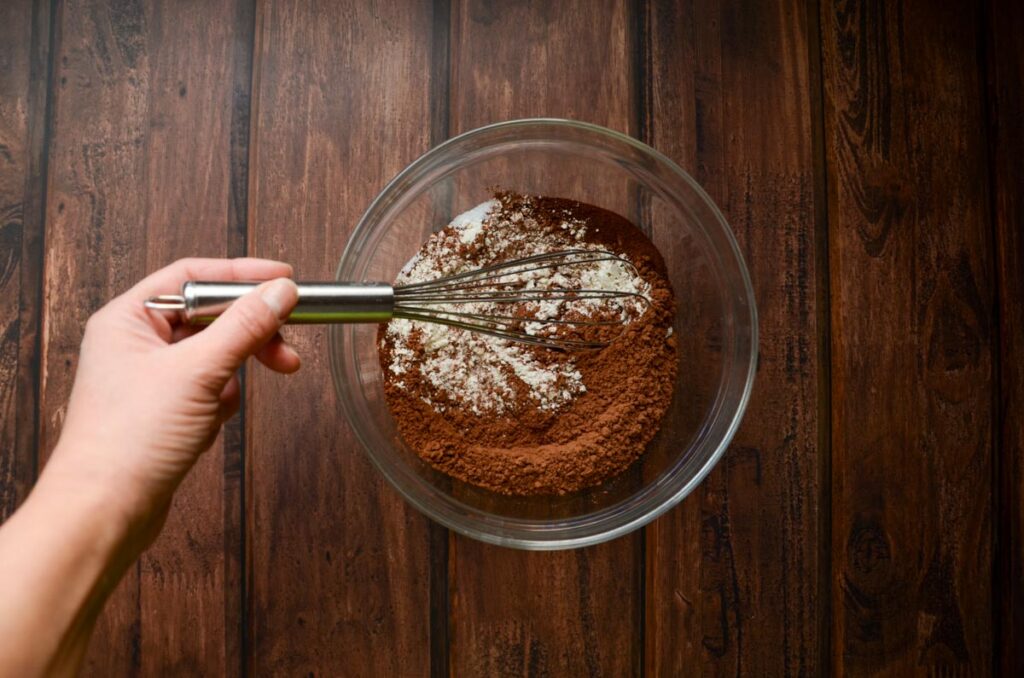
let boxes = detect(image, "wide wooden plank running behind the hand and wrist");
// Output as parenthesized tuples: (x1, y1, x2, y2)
(41, 0, 251, 675)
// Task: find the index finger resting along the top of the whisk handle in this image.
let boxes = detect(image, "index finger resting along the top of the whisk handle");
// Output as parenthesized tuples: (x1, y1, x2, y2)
(121, 257, 292, 304)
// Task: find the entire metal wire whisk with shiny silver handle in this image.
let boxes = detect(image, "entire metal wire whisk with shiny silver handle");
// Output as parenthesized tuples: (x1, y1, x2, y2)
(145, 250, 650, 350)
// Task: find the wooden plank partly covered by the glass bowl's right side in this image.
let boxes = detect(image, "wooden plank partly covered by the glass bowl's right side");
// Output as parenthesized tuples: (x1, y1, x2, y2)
(642, 0, 826, 676)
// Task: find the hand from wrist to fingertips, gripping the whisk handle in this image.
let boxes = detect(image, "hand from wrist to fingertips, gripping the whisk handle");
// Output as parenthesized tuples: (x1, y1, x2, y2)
(41, 259, 299, 548)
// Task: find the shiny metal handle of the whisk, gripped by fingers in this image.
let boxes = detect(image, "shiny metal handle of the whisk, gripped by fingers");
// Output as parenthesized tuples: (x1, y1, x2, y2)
(145, 281, 394, 325)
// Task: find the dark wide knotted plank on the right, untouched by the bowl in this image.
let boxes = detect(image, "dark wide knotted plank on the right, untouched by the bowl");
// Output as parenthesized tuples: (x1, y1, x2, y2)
(821, 1, 995, 676)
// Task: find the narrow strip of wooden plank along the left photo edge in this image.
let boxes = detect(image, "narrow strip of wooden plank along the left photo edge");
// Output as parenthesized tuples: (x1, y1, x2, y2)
(0, 0, 50, 522)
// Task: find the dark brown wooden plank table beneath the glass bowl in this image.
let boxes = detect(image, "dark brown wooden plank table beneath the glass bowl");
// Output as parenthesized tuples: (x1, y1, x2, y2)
(0, 0, 1024, 676)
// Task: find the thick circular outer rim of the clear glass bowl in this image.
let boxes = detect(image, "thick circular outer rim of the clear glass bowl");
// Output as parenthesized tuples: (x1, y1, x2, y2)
(327, 118, 760, 551)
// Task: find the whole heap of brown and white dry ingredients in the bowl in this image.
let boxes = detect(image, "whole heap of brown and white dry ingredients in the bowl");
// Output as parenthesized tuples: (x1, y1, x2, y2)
(378, 193, 677, 495)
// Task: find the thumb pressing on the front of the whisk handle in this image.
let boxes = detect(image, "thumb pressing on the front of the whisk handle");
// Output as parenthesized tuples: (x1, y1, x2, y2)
(191, 278, 299, 377)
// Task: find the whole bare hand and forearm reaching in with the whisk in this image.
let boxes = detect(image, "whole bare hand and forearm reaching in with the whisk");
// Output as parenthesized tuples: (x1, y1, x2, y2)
(0, 259, 299, 676)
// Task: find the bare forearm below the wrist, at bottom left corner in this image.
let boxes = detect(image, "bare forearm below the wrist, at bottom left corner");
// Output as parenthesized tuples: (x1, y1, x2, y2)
(0, 450, 143, 676)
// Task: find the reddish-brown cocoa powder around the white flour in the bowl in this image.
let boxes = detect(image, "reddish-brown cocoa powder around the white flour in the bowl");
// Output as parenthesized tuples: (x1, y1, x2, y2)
(378, 194, 677, 495)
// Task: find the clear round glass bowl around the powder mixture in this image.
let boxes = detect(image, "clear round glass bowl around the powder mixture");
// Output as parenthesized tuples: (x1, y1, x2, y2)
(330, 119, 757, 549)
